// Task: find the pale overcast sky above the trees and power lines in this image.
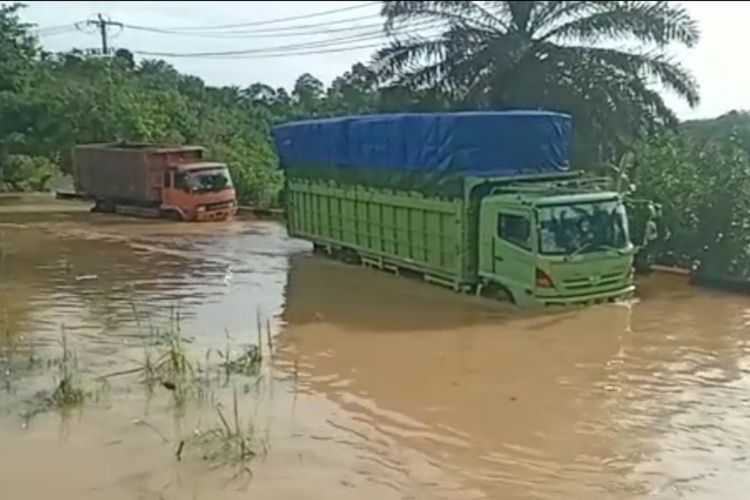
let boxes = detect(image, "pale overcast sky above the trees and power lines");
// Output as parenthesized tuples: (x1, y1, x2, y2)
(11, 1, 750, 119)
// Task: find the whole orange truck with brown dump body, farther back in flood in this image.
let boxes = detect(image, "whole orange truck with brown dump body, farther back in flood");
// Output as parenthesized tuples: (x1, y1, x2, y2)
(73, 143, 237, 221)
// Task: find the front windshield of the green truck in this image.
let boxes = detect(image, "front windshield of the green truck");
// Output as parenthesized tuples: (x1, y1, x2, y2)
(538, 200, 629, 255)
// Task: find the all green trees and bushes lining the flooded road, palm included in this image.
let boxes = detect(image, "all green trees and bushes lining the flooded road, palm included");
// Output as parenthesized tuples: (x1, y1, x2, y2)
(0, 1, 750, 272)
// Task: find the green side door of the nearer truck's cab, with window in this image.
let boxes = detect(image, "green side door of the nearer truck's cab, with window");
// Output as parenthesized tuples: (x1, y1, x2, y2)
(482, 205, 536, 302)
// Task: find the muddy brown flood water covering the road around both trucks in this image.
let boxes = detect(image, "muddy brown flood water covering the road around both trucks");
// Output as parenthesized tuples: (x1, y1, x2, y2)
(0, 200, 750, 500)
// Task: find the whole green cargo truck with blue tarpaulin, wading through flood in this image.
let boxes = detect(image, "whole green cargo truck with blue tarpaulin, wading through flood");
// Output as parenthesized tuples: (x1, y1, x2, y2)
(273, 111, 636, 305)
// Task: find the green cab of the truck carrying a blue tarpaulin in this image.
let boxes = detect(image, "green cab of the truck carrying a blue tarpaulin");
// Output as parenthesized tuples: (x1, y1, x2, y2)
(478, 188, 635, 305)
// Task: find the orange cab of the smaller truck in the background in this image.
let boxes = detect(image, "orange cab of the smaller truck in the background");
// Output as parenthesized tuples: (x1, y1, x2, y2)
(161, 162, 237, 221)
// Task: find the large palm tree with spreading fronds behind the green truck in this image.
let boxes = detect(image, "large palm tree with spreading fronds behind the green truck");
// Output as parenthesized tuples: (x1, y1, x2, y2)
(376, 1, 699, 165)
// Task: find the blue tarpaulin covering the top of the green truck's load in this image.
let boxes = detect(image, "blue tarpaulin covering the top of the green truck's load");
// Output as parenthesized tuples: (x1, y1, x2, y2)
(273, 111, 571, 176)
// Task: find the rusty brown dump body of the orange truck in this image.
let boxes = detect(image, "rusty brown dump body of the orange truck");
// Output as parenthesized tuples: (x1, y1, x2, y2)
(73, 144, 204, 204)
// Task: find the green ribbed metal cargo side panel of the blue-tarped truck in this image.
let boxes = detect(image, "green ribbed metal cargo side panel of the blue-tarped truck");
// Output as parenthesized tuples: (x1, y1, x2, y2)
(286, 179, 470, 289)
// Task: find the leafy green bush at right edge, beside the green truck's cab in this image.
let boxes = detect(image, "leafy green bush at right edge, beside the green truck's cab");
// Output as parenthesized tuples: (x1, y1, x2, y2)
(630, 134, 750, 273)
